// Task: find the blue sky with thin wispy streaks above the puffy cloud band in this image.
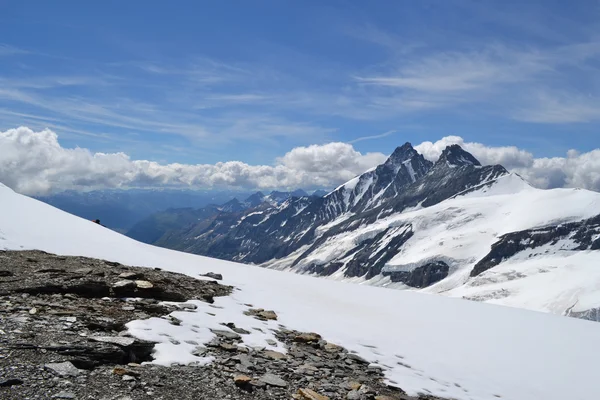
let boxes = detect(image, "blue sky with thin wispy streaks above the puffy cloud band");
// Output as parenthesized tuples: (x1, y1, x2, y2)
(0, 0, 600, 164)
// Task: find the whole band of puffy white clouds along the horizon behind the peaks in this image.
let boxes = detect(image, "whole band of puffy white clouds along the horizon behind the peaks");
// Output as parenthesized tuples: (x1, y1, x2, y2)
(0, 127, 600, 195)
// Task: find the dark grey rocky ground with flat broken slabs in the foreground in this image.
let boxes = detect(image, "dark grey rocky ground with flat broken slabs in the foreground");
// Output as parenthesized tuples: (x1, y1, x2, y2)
(0, 251, 436, 400)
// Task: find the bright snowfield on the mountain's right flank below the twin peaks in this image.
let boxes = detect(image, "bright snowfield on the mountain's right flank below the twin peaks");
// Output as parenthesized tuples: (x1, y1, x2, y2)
(264, 174, 600, 315)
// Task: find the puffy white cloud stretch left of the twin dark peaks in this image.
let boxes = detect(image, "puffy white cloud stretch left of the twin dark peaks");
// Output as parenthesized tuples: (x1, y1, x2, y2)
(0, 127, 386, 194)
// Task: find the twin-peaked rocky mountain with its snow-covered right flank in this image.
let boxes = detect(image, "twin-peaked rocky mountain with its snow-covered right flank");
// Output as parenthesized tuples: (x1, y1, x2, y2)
(154, 143, 600, 320)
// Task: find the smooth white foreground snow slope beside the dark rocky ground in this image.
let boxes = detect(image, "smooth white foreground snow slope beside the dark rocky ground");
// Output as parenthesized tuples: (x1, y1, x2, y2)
(0, 182, 600, 400)
